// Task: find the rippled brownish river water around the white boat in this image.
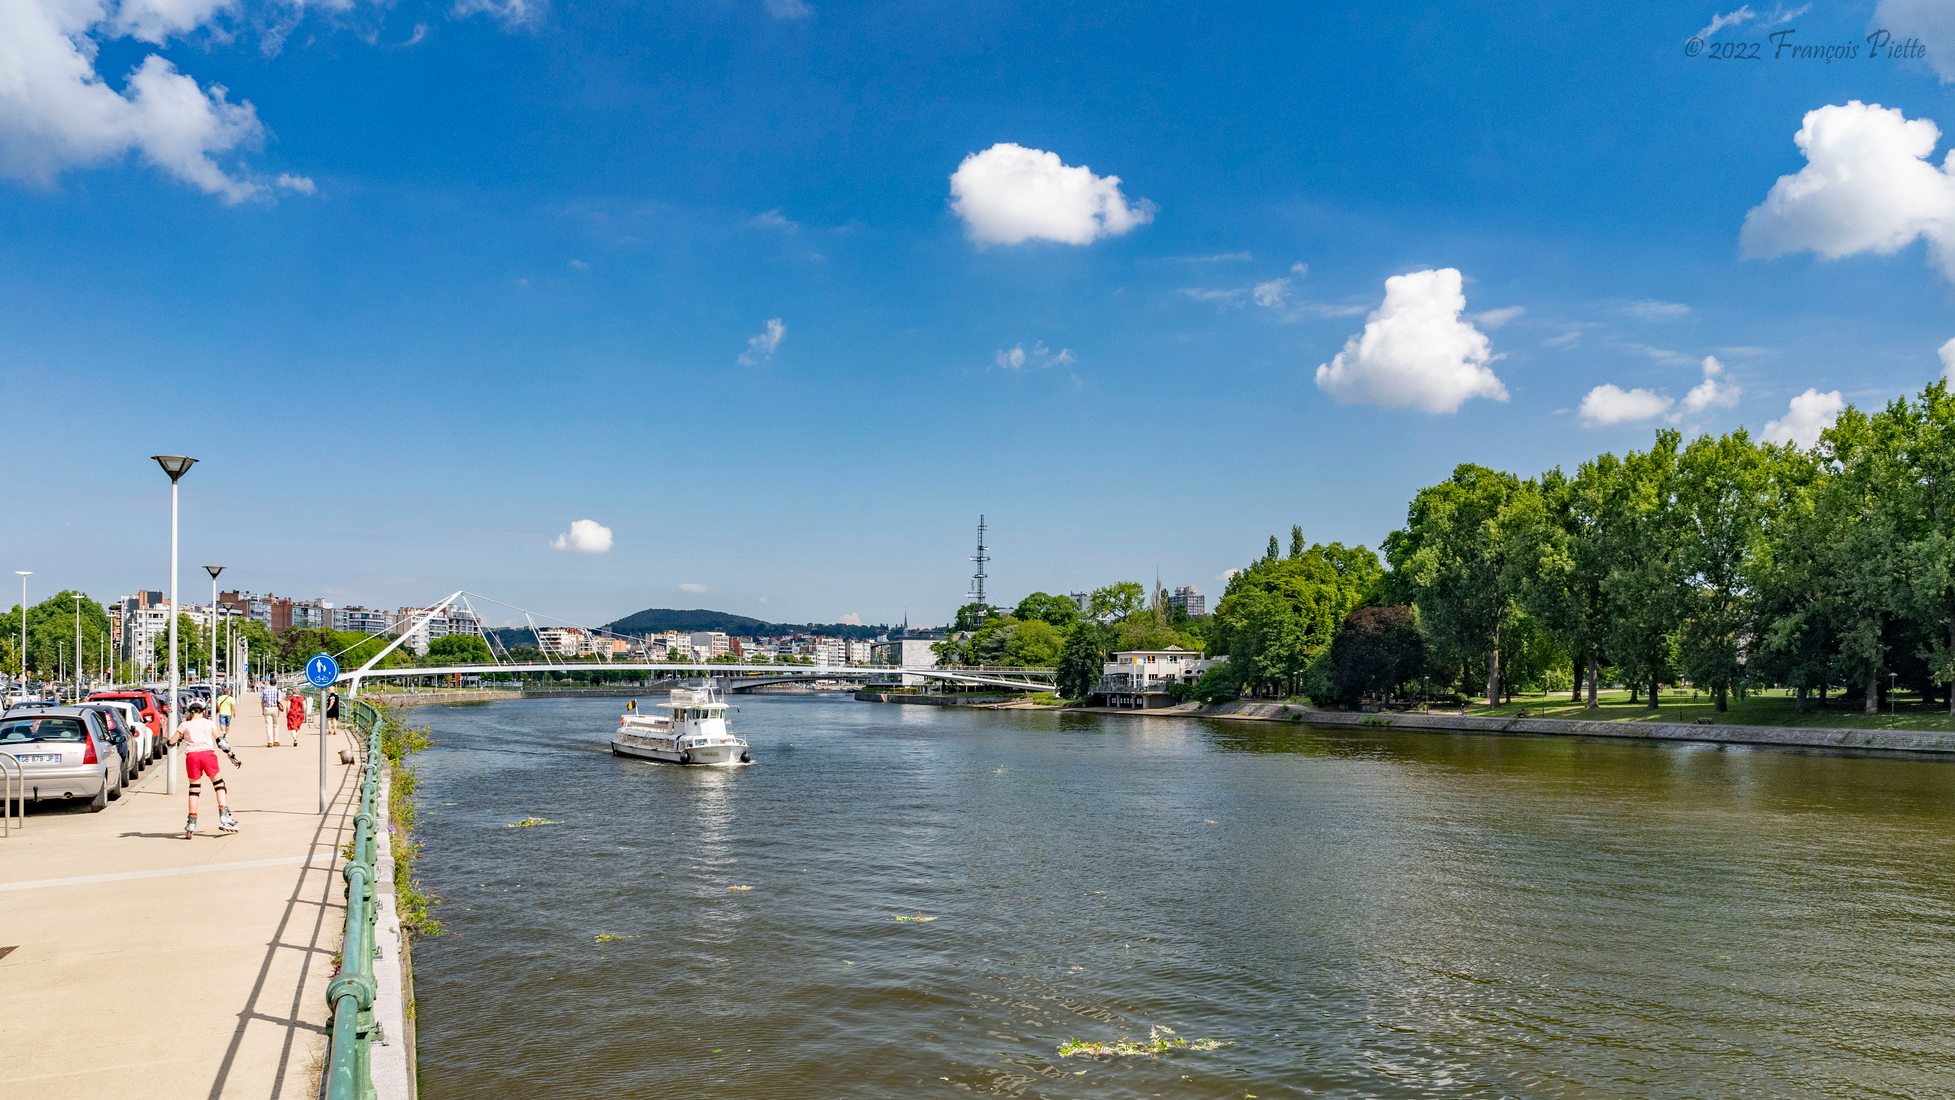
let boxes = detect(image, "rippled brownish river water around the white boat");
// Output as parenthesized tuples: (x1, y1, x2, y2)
(414, 698, 1955, 1100)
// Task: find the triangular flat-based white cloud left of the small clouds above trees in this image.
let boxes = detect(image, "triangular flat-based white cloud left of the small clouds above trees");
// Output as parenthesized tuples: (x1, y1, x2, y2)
(1318, 268, 1507, 412)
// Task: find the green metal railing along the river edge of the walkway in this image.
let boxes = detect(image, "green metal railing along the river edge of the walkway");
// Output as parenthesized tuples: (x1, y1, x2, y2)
(326, 699, 385, 1100)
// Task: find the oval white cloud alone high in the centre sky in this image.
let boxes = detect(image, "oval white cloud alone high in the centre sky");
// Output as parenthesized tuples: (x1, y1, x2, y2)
(950, 141, 1153, 244)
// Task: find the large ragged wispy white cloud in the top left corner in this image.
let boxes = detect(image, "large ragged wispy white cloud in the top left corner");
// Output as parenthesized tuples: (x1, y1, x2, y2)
(0, 0, 277, 203)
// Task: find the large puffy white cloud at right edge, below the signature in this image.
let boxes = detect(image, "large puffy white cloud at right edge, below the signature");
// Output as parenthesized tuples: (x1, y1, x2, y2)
(1738, 100, 1955, 279)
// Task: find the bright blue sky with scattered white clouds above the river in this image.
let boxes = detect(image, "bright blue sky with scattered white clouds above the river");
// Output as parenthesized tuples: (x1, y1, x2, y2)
(0, 0, 1955, 621)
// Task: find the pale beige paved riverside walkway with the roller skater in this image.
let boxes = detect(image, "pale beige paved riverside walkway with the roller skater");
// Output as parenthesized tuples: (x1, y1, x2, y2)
(0, 698, 360, 1100)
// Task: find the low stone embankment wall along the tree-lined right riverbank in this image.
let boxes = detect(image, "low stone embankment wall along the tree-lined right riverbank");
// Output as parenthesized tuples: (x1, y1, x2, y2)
(1075, 699, 1955, 756)
